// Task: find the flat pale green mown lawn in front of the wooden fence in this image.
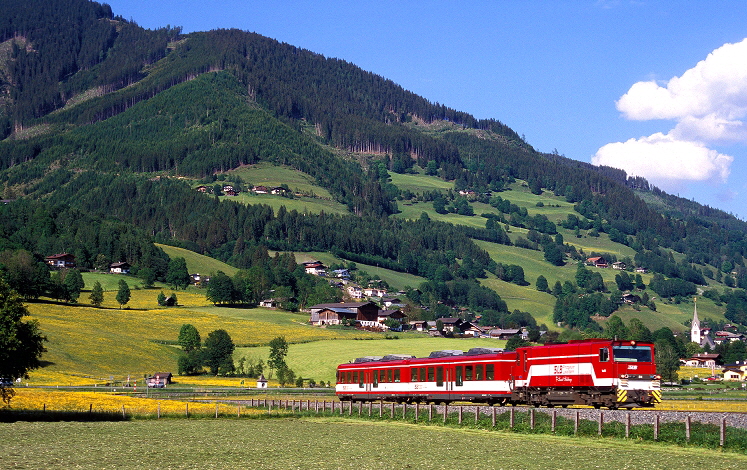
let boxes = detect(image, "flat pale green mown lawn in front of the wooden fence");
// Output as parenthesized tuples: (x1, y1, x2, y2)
(0, 418, 747, 469)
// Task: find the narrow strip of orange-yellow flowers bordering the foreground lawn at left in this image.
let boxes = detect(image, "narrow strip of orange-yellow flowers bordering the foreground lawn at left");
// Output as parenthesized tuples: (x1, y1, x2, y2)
(5, 389, 266, 416)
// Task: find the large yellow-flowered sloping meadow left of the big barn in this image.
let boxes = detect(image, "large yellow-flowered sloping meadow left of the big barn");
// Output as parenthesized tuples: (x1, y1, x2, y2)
(27, 290, 381, 385)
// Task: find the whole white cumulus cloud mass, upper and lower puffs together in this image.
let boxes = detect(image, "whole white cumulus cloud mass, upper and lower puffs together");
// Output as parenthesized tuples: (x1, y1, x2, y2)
(592, 39, 747, 184)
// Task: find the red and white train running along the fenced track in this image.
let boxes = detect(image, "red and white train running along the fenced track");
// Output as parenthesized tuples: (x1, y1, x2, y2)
(336, 339, 661, 409)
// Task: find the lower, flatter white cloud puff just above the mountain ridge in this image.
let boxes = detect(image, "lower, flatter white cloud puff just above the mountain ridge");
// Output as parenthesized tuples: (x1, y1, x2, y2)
(591, 133, 733, 183)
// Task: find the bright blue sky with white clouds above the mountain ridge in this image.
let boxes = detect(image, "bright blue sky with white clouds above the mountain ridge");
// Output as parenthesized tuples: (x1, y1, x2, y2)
(108, 0, 747, 219)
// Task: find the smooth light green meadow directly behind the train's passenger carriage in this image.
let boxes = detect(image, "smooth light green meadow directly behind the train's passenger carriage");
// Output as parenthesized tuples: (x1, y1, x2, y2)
(234, 333, 506, 383)
